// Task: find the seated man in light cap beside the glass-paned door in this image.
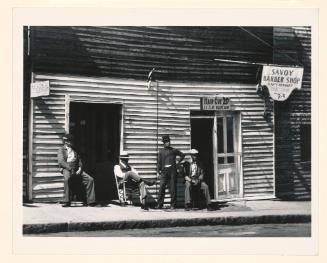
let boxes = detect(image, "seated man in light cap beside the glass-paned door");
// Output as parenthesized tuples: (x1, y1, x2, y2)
(185, 149, 213, 211)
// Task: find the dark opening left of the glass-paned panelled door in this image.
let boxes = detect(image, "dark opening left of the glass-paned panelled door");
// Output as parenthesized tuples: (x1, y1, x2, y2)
(191, 118, 214, 198)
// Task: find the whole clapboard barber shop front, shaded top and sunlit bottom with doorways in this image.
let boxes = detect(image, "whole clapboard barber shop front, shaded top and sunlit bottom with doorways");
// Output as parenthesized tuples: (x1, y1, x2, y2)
(26, 27, 312, 204)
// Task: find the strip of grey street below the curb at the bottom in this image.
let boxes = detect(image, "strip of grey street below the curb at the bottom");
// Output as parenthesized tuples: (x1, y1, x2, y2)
(30, 223, 311, 237)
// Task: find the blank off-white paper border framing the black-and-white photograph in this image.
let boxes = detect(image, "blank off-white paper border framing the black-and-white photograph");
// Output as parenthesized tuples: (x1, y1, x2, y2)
(7, 4, 318, 255)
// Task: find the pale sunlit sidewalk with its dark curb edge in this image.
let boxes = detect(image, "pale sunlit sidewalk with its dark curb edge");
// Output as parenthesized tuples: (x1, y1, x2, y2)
(23, 200, 311, 234)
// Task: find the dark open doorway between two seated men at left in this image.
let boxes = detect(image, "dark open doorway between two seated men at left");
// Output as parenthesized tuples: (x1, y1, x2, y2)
(69, 102, 122, 202)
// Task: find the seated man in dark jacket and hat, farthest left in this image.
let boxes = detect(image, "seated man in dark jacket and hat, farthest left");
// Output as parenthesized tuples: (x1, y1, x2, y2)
(58, 134, 95, 207)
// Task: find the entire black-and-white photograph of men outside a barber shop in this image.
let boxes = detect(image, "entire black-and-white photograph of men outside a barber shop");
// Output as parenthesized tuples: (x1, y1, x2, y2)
(9, 6, 314, 258)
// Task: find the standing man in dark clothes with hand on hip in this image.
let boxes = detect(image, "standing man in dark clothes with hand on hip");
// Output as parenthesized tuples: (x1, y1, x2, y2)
(156, 135, 185, 209)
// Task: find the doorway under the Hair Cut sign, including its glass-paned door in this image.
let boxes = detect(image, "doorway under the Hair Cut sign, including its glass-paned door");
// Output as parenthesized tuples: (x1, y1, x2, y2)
(191, 111, 242, 200)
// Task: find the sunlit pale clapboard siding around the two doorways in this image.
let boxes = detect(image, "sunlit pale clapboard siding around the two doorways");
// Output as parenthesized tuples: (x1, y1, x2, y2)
(33, 74, 274, 204)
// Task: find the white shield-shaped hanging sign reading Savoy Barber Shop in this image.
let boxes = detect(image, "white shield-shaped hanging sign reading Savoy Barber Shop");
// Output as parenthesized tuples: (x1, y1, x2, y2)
(261, 65, 303, 101)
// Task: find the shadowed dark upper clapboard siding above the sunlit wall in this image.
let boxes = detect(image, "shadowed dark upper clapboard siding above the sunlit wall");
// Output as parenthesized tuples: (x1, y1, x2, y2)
(31, 26, 273, 83)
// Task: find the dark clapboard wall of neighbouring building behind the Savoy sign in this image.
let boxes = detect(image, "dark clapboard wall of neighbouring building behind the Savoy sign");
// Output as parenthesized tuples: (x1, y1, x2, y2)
(274, 27, 311, 199)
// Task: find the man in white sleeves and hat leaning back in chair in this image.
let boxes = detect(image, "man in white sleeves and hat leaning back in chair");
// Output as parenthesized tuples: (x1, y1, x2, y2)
(114, 151, 155, 210)
